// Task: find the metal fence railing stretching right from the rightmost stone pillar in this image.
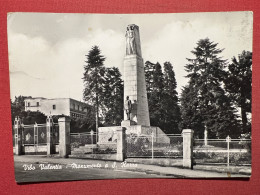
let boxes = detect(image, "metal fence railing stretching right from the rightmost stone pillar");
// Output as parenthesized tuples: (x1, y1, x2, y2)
(193, 137, 251, 166)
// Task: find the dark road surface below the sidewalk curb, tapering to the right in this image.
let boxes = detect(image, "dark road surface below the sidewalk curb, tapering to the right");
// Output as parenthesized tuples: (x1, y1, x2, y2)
(15, 162, 172, 183)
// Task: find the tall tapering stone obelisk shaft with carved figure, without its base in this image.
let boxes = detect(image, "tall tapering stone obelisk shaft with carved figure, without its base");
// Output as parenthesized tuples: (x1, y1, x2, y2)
(124, 24, 150, 126)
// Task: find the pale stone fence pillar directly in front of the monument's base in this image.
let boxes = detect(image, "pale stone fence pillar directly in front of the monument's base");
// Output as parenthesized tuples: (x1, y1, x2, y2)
(116, 127, 126, 161)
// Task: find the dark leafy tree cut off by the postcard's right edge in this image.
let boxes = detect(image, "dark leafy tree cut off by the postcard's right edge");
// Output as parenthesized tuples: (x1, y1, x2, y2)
(225, 51, 252, 133)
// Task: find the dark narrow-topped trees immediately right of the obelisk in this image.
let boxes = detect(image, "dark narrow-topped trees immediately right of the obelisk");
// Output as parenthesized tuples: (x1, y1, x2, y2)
(145, 61, 181, 133)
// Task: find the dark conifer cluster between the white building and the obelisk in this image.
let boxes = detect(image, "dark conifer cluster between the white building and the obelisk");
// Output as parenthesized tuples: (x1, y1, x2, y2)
(83, 46, 123, 128)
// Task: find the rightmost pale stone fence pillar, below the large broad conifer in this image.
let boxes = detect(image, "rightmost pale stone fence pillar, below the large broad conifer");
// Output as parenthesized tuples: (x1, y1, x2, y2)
(182, 129, 194, 169)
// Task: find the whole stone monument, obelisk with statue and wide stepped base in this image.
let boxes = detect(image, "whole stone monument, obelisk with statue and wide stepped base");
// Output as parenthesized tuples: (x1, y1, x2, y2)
(98, 24, 170, 144)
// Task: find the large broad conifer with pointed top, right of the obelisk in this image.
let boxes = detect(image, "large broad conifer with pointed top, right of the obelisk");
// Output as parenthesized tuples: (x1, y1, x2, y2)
(181, 38, 239, 138)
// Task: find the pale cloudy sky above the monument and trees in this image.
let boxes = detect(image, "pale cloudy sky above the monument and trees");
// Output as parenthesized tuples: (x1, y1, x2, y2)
(7, 12, 253, 101)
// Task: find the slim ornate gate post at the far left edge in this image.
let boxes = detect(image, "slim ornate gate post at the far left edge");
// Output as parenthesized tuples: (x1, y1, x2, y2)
(14, 117, 22, 155)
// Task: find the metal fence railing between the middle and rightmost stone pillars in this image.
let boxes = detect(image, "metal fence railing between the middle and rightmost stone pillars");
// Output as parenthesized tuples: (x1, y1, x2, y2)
(126, 133, 183, 159)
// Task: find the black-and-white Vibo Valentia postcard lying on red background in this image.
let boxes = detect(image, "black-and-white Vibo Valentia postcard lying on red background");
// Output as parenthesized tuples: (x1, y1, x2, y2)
(7, 11, 253, 183)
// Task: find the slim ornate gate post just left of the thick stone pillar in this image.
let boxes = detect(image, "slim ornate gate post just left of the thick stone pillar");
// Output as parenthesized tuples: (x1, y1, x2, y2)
(46, 116, 55, 155)
